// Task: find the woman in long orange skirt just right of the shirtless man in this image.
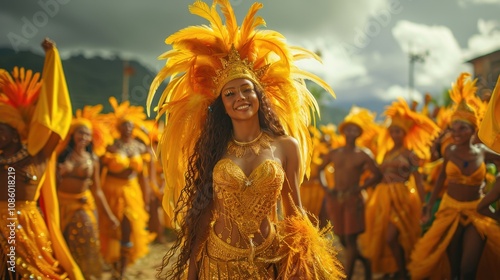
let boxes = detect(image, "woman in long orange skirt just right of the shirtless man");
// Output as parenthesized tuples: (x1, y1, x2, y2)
(360, 98, 438, 279)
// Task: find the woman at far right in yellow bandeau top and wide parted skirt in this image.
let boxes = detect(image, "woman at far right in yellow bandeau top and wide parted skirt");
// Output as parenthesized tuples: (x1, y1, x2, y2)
(409, 73, 500, 279)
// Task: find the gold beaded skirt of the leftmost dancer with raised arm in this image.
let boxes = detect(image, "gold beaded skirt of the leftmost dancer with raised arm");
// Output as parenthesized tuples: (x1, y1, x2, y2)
(0, 201, 69, 279)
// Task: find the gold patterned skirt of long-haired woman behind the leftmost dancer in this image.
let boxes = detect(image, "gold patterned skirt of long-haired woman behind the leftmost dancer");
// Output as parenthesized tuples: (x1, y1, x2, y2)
(57, 190, 102, 279)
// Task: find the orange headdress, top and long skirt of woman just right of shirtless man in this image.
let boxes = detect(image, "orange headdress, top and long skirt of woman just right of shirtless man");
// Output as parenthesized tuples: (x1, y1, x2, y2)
(360, 99, 438, 273)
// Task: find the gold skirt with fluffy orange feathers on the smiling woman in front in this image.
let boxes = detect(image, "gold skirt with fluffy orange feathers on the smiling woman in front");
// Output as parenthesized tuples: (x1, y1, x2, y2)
(198, 215, 345, 280)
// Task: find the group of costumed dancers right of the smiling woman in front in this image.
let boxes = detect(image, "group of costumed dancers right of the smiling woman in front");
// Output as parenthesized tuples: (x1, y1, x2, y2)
(300, 73, 500, 279)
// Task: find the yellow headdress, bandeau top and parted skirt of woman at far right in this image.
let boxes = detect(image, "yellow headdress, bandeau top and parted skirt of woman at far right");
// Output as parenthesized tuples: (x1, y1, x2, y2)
(408, 73, 500, 279)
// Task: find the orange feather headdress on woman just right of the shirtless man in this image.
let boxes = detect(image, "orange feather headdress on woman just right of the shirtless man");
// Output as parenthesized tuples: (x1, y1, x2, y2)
(377, 98, 440, 162)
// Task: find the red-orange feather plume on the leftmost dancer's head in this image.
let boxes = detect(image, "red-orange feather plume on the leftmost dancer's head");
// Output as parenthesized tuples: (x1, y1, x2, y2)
(0, 66, 42, 142)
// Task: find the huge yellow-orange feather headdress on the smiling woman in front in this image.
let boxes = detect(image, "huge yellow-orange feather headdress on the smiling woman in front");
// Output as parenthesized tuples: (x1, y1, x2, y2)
(147, 0, 334, 218)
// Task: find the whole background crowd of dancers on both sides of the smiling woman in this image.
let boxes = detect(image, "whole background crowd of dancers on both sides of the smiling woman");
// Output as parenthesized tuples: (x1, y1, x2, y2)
(0, 14, 500, 280)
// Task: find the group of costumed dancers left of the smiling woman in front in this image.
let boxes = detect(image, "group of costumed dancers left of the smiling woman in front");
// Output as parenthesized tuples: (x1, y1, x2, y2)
(0, 39, 162, 279)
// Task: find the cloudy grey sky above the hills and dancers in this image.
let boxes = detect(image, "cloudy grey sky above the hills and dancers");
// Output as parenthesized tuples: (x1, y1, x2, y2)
(0, 0, 500, 113)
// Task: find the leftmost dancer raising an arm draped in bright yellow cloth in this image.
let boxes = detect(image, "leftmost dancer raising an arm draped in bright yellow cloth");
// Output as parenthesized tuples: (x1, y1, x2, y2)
(0, 39, 83, 280)
